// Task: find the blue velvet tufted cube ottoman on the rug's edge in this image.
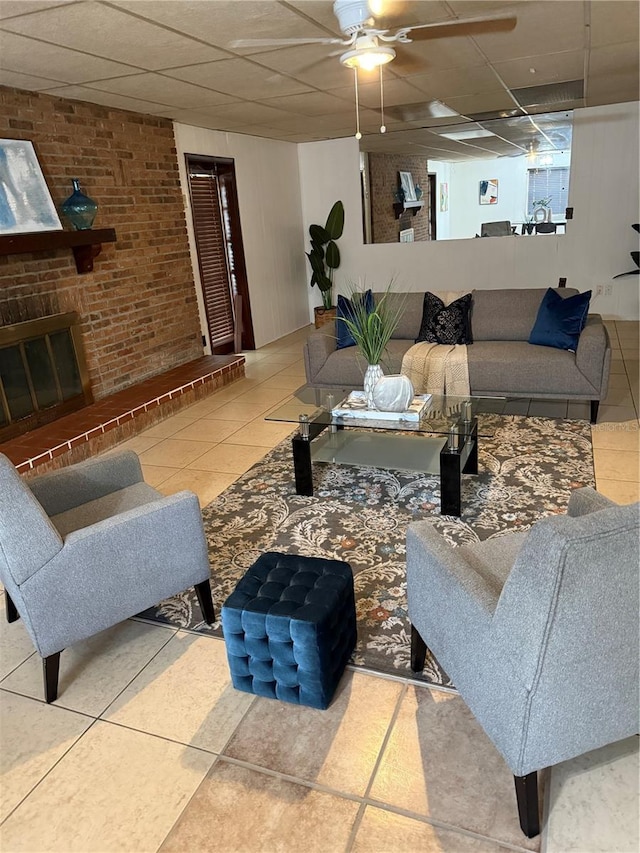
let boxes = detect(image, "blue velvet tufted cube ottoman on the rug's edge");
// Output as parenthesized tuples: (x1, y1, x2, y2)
(222, 551, 356, 708)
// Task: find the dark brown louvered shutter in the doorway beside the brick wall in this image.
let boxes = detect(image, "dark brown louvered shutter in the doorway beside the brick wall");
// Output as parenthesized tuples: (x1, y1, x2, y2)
(189, 172, 234, 347)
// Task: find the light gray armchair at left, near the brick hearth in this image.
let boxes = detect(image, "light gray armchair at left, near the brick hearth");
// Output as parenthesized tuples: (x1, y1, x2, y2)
(0, 451, 214, 702)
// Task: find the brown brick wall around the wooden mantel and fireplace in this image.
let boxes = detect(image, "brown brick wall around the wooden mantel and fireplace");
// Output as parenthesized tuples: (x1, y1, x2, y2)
(0, 87, 202, 399)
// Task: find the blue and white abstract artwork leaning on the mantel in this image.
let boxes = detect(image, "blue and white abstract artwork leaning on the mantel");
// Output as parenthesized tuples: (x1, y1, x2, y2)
(0, 139, 62, 234)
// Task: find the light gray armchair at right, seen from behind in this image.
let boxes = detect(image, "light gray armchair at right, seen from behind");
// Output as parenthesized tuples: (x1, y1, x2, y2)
(407, 488, 640, 837)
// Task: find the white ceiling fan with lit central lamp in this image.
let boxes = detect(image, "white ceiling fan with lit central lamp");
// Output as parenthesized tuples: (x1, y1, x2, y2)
(231, 0, 516, 71)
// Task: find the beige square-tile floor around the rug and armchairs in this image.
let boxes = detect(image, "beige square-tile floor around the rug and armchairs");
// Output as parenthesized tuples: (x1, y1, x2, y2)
(0, 322, 640, 853)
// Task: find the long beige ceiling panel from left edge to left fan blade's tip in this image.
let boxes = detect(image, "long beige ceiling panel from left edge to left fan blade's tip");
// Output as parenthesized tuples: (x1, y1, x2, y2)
(3, 2, 227, 71)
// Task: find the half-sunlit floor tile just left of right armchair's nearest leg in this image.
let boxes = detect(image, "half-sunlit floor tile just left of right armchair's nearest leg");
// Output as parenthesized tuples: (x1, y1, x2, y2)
(370, 686, 540, 850)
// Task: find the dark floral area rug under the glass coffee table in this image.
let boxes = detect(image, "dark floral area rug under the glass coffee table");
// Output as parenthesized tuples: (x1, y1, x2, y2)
(140, 414, 595, 686)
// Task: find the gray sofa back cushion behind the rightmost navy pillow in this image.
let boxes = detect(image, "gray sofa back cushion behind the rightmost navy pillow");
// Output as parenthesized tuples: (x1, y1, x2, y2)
(471, 287, 578, 342)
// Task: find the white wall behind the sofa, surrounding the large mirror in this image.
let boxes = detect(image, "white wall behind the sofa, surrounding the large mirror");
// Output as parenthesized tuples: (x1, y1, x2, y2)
(298, 103, 640, 320)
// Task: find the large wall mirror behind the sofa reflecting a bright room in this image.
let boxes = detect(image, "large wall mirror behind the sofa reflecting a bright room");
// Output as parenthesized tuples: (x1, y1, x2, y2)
(360, 110, 573, 243)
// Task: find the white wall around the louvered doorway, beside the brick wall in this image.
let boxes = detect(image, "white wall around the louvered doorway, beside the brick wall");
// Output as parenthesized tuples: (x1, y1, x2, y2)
(174, 124, 308, 347)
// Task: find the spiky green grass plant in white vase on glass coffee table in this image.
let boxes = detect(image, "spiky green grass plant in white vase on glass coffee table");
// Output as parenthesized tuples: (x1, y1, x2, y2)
(336, 281, 404, 409)
